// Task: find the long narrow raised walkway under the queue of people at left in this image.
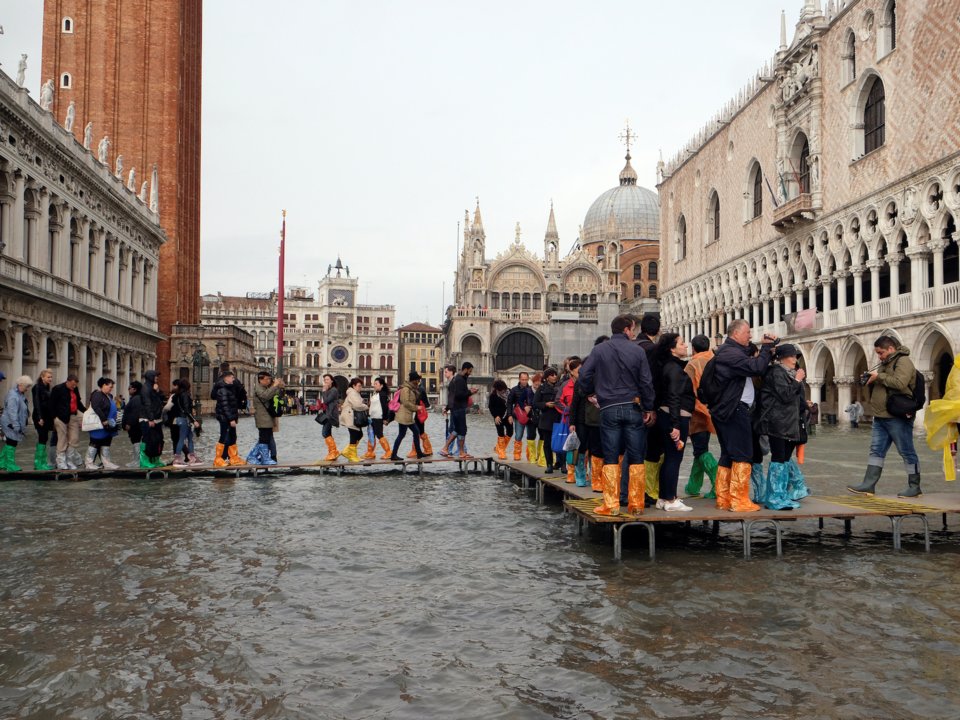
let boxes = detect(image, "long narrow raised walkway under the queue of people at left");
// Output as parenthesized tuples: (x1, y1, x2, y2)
(0, 455, 493, 482)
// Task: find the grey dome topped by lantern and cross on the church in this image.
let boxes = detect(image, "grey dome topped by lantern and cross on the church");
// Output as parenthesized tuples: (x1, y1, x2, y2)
(580, 152, 660, 245)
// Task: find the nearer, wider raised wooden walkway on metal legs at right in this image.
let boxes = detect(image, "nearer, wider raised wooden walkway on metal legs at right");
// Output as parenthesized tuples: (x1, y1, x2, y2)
(496, 460, 960, 560)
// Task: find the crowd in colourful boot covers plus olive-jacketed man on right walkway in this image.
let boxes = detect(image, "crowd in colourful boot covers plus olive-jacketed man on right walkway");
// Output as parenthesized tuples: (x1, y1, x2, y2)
(480, 315, 922, 515)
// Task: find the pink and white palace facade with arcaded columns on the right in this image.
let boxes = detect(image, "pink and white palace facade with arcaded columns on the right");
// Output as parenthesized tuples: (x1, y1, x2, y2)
(659, 0, 960, 427)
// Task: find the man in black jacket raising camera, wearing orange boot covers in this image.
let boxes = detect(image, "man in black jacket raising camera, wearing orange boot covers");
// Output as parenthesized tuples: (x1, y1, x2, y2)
(710, 319, 778, 512)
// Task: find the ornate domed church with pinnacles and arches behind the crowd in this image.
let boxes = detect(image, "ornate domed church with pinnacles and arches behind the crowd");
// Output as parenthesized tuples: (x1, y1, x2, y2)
(443, 151, 659, 383)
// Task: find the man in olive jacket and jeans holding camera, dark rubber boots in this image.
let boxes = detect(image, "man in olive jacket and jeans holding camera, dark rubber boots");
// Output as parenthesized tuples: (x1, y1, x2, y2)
(847, 335, 923, 497)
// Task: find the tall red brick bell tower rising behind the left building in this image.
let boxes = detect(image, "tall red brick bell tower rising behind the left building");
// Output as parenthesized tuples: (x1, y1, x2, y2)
(42, 0, 202, 380)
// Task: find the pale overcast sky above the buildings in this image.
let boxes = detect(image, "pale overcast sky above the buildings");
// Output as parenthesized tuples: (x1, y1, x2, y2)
(0, 0, 803, 324)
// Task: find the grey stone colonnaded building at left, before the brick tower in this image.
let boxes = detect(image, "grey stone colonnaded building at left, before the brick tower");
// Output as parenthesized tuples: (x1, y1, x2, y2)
(0, 66, 165, 398)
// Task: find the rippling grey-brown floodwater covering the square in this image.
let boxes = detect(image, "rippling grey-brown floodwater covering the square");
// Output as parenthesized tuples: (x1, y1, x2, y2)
(0, 417, 960, 718)
